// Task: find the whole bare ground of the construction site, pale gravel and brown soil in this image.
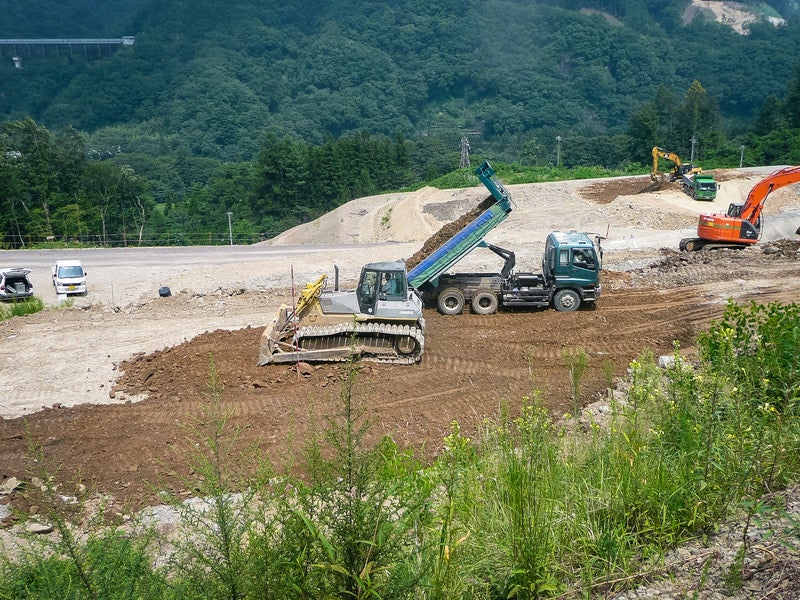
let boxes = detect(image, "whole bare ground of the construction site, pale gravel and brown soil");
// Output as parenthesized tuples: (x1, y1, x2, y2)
(0, 169, 800, 510)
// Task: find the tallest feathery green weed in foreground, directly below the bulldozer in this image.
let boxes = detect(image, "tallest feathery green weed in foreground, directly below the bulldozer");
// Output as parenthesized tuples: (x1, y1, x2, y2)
(296, 360, 429, 598)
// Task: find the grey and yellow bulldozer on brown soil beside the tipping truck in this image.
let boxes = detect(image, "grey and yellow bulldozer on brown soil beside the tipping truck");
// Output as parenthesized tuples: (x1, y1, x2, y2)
(258, 261, 425, 366)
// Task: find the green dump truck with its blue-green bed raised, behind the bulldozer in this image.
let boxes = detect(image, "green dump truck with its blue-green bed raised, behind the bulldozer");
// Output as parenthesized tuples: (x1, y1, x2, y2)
(408, 162, 602, 315)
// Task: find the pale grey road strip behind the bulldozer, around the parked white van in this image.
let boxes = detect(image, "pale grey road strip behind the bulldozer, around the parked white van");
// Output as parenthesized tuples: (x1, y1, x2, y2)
(0, 243, 418, 305)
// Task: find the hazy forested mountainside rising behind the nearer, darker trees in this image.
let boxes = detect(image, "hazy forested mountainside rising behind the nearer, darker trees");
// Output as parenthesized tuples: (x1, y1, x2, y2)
(0, 0, 800, 160)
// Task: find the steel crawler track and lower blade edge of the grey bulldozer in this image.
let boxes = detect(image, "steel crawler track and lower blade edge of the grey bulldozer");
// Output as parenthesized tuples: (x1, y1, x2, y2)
(268, 321, 425, 365)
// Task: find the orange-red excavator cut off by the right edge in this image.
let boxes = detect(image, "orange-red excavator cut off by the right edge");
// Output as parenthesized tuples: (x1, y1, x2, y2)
(680, 166, 800, 251)
